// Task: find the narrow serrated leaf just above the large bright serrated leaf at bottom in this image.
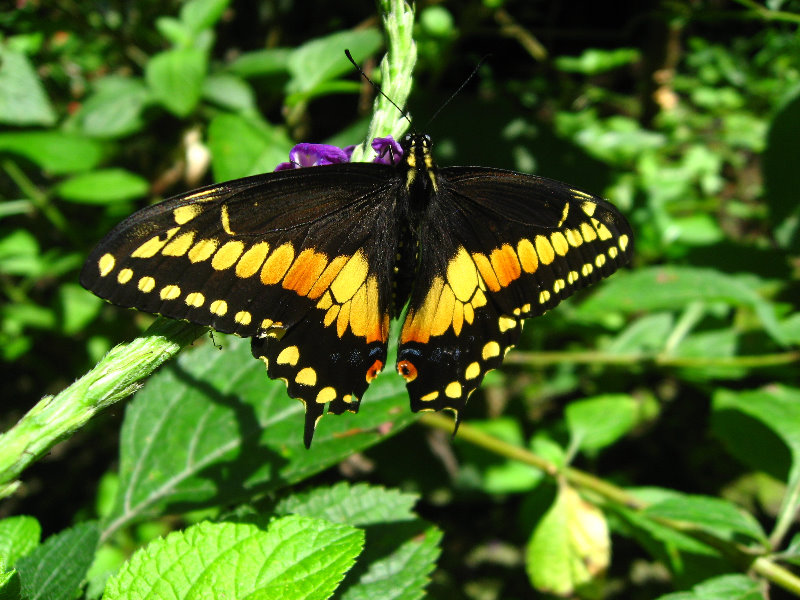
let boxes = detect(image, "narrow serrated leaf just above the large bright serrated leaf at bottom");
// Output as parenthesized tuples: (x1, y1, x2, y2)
(275, 482, 419, 527)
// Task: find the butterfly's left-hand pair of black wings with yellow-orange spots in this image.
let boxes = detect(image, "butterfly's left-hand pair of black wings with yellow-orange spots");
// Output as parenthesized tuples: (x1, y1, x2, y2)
(80, 163, 400, 444)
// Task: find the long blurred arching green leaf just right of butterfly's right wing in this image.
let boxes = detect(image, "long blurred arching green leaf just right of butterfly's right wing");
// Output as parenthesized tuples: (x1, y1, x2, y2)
(575, 267, 784, 343)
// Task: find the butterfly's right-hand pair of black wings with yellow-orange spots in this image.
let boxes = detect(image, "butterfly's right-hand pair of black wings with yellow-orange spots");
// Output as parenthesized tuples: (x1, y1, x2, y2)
(397, 167, 633, 421)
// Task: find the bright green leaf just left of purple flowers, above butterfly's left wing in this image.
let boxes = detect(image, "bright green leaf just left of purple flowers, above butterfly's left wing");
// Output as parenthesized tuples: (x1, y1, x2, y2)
(208, 114, 294, 181)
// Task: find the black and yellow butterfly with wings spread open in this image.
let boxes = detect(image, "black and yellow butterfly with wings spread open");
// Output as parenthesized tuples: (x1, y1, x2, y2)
(81, 134, 633, 446)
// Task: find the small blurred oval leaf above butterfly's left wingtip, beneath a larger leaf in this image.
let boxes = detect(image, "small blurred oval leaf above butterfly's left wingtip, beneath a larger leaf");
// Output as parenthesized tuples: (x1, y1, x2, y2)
(55, 169, 150, 204)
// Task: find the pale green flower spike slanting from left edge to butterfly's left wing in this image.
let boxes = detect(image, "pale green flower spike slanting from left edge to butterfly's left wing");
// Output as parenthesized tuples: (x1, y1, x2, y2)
(0, 319, 206, 498)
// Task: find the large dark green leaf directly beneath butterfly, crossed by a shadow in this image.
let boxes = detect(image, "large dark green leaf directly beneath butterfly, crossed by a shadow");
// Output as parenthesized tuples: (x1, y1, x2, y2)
(106, 334, 416, 529)
